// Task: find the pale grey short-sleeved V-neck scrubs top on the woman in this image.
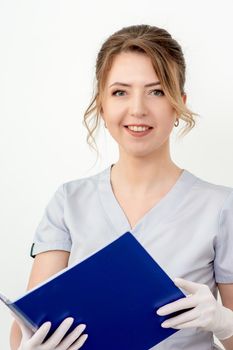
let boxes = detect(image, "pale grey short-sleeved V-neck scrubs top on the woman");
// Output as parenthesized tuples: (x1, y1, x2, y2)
(31, 165, 233, 350)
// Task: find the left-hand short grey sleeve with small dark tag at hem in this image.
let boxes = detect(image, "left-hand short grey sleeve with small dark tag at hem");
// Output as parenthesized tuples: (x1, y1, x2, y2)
(30, 184, 72, 258)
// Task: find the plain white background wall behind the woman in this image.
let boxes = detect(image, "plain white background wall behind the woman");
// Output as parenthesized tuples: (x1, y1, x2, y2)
(0, 0, 233, 350)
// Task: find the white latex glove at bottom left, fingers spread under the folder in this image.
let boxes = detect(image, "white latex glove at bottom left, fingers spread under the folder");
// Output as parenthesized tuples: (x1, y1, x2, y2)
(11, 312, 88, 350)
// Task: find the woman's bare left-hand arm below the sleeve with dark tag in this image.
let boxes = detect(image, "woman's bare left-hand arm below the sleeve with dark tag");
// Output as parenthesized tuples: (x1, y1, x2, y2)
(10, 250, 70, 350)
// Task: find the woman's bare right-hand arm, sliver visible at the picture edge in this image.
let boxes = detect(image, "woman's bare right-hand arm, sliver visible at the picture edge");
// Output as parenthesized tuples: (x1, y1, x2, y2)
(218, 283, 233, 350)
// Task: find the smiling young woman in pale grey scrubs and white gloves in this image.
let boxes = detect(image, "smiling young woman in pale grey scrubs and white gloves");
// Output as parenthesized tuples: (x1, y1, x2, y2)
(11, 25, 233, 350)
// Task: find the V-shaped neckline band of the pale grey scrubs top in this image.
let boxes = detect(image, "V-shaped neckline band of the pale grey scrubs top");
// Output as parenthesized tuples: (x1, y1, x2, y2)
(98, 164, 198, 235)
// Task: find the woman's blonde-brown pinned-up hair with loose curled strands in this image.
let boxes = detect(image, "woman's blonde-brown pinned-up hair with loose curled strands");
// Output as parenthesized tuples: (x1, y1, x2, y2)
(83, 24, 198, 153)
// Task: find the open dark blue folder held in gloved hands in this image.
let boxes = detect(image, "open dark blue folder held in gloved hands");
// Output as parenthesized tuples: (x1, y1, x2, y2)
(1, 232, 190, 350)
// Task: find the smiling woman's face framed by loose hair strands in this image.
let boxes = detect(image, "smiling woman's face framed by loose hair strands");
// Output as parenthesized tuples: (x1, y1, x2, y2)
(102, 52, 186, 156)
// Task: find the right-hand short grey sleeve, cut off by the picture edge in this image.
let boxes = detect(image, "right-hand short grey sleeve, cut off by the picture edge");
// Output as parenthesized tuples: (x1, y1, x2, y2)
(214, 190, 233, 283)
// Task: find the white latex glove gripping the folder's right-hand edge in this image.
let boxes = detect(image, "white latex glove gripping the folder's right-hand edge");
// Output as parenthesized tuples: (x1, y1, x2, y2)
(156, 278, 233, 340)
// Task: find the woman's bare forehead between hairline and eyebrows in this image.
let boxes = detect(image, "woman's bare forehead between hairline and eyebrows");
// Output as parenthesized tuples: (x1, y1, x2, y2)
(107, 52, 158, 84)
